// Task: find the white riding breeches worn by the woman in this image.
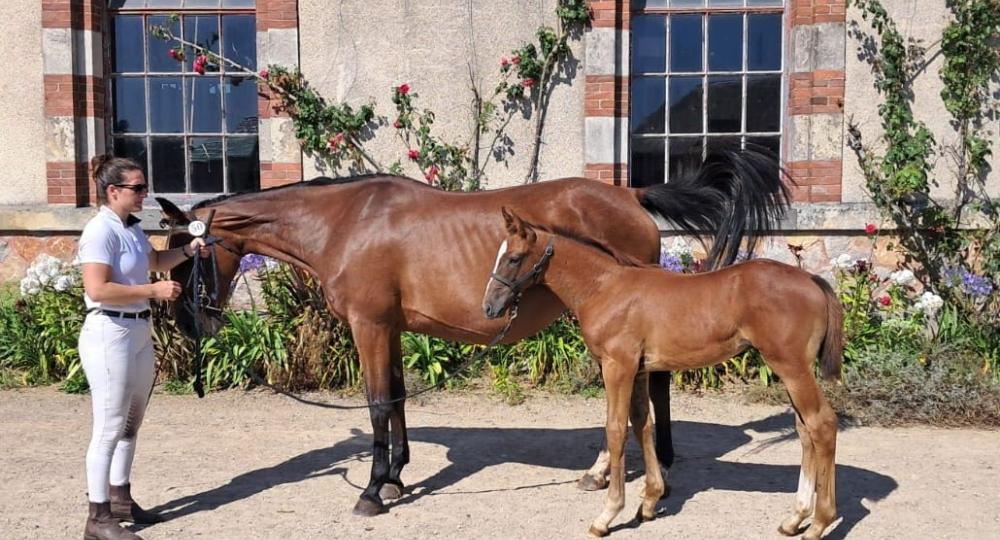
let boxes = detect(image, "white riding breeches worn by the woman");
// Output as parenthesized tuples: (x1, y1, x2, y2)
(79, 313, 155, 503)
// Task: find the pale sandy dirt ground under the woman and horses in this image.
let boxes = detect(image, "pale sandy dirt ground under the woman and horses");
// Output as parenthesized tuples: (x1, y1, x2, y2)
(0, 388, 1000, 540)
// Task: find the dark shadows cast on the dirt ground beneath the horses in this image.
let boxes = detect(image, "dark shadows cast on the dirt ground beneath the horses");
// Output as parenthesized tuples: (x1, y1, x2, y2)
(153, 414, 898, 538)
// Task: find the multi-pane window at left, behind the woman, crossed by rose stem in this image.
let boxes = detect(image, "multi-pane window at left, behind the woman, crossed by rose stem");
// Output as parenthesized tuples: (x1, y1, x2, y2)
(108, 0, 260, 194)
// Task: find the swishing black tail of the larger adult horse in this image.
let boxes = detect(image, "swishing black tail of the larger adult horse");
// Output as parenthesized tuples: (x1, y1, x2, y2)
(639, 149, 790, 268)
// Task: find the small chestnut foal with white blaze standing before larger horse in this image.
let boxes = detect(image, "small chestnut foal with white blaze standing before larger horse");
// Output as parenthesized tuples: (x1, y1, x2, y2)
(481, 209, 843, 540)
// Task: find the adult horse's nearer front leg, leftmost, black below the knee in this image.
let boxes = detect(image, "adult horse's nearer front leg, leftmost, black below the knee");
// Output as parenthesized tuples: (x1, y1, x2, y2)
(351, 320, 394, 516)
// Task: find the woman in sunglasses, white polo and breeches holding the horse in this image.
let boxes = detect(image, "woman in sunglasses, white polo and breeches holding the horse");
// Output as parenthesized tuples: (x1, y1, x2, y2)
(79, 156, 208, 540)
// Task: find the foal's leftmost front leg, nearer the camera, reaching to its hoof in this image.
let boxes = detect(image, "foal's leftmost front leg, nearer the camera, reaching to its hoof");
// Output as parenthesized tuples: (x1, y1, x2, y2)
(589, 360, 636, 536)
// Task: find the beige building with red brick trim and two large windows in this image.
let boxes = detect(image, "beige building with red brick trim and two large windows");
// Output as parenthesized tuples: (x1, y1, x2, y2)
(0, 0, 1000, 281)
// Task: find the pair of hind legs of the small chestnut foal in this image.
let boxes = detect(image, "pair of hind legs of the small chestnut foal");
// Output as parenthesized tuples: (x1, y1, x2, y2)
(765, 360, 837, 540)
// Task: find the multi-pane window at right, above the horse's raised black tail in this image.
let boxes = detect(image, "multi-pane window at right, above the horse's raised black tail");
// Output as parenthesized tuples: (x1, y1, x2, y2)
(629, 0, 784, 186)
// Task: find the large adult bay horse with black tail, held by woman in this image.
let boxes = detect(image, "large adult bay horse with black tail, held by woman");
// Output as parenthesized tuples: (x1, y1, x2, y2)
(157, 150, 788, 515)
